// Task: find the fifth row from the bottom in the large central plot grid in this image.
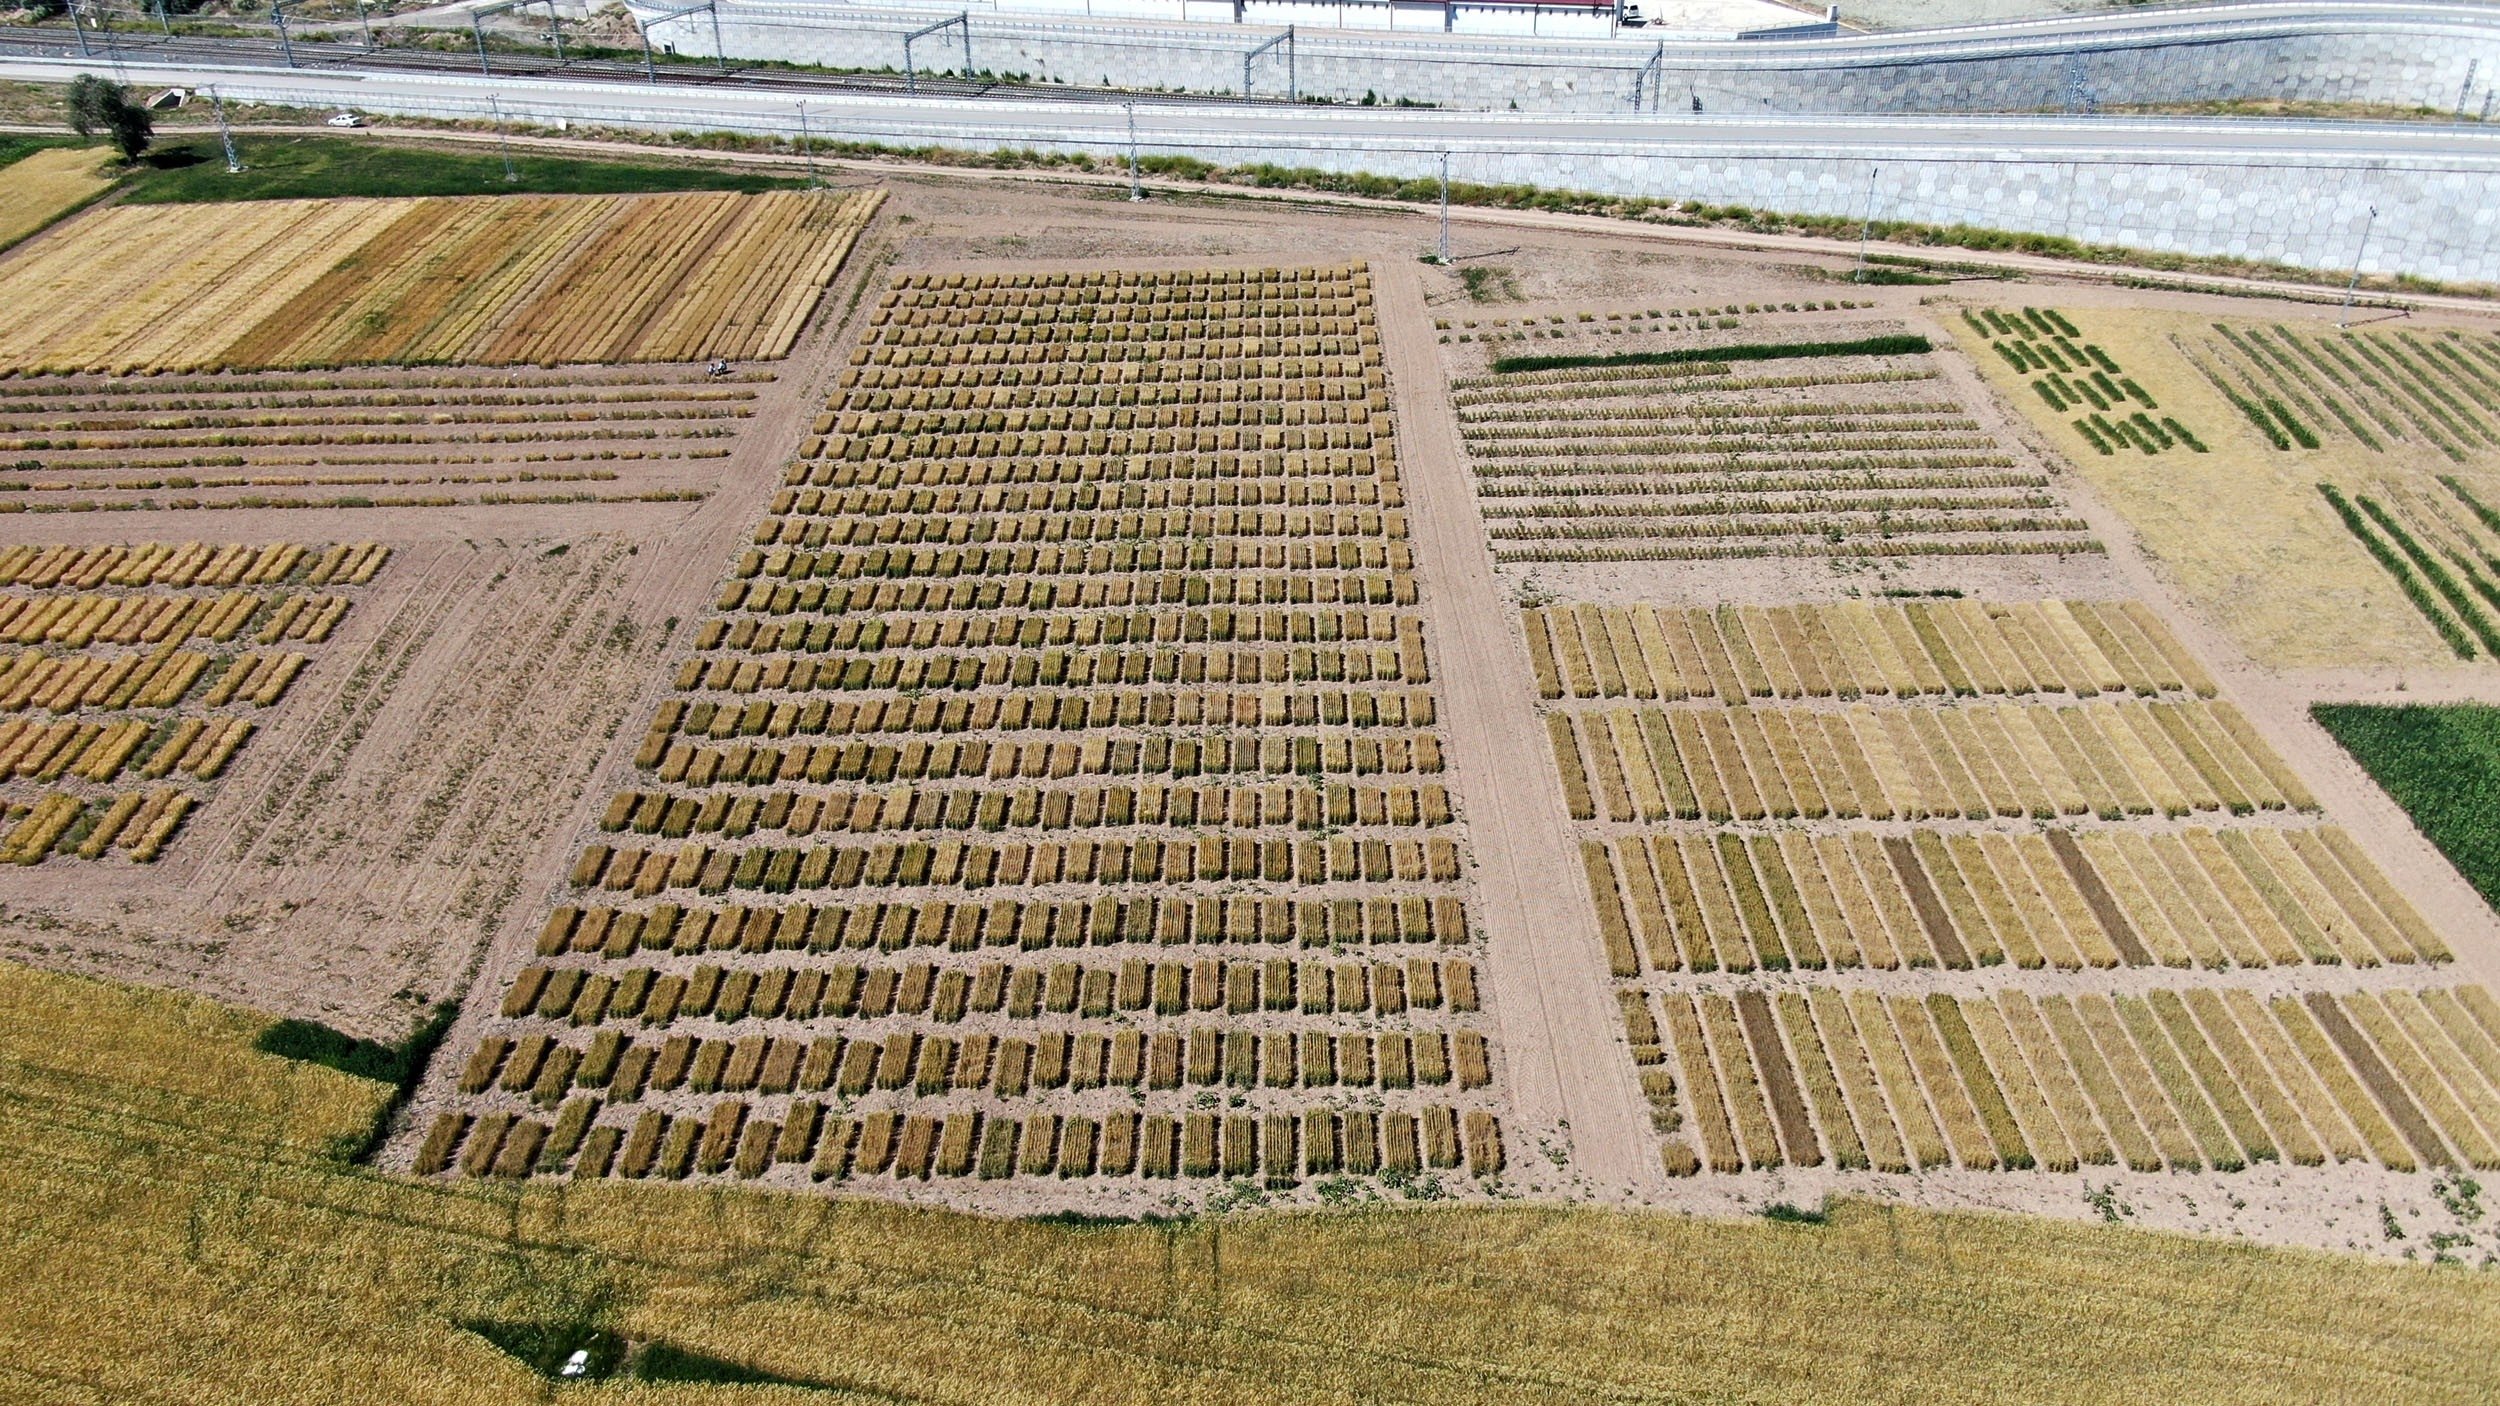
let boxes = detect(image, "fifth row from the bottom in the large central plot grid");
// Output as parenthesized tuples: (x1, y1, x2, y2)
(573, 833, 1460, 898)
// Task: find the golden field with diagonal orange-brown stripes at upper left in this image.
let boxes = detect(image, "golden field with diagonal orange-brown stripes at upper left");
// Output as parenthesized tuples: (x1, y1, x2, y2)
(0, 190, 880, 373)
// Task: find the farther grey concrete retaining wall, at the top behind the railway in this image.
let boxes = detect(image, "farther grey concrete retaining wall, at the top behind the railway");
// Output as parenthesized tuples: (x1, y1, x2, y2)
(643, 0, 2500, 115)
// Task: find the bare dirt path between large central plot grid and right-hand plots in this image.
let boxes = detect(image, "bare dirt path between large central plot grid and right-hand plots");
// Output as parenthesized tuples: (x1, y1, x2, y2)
(1378, 265, 1663, 1198)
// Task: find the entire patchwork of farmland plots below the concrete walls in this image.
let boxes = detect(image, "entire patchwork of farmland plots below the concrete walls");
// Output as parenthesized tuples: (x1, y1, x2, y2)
(0, 81, 2500, 1401)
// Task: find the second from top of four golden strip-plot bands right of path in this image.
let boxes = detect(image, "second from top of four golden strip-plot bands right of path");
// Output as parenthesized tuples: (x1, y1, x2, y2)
(1545, 703, 2315, 821)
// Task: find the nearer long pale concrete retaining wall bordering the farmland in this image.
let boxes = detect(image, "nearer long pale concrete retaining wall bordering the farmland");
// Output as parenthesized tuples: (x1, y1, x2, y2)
(141, 65, 2500, 283)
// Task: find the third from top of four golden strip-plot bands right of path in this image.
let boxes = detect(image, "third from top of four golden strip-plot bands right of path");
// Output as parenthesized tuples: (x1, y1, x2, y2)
(1580, 828, 2448, 976)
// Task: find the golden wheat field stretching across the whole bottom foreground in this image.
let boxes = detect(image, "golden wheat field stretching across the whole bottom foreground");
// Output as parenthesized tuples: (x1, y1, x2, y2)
(0, 950, 2500, 1403)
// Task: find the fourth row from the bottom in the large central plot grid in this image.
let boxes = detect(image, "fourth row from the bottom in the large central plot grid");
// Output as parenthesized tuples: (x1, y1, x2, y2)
(535, 893, 1468, 961)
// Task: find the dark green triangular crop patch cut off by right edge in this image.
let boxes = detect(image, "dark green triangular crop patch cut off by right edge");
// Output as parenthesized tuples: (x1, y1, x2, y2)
(2310, 703, 2500, 908)
